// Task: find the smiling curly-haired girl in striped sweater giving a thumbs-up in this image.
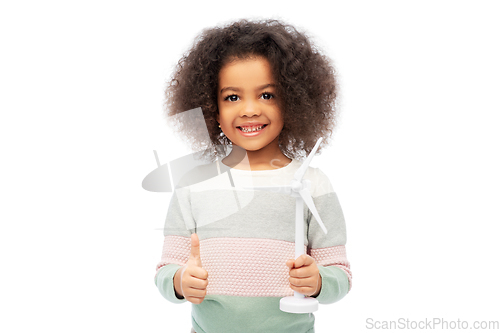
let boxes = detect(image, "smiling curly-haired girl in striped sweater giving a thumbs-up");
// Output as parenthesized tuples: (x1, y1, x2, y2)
(155, 20, 351, 333)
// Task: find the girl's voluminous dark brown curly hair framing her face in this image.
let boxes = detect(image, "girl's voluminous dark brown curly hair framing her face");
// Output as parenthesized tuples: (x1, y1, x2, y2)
(165, 20, 337, 161)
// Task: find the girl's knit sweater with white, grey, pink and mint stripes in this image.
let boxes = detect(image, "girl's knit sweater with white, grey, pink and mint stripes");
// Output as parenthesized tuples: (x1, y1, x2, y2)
(155, 160, 351, 333)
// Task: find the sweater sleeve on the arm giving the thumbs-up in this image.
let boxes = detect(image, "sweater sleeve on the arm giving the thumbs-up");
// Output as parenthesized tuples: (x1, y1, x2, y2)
(154, 188, 194, 303)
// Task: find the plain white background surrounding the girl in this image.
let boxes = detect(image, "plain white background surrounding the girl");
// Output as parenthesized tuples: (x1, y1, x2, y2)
(0, 1, 500, 333)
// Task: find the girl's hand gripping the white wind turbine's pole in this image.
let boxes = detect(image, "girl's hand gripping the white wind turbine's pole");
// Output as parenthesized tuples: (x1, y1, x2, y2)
(286, 254, 321, 297)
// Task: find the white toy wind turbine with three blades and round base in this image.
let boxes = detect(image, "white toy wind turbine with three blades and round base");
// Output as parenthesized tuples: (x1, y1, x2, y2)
(248, 138, 327, 313)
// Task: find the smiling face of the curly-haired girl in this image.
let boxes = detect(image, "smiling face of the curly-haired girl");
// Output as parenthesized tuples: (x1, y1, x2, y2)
(217, 57, 283, 151)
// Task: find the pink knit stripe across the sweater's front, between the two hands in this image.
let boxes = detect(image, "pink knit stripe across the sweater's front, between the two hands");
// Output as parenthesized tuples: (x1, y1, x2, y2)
(200, 238, 295, 297)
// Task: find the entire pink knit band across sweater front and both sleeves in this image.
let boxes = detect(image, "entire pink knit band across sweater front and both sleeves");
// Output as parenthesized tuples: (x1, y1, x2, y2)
(156, 236, 351, 297)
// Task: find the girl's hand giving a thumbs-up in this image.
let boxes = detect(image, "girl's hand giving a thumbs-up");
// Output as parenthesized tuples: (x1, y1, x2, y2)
(174, 234, 208, 304)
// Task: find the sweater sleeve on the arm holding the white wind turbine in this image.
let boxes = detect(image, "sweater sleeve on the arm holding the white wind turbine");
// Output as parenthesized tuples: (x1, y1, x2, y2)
(308, 169, 352, 304)
